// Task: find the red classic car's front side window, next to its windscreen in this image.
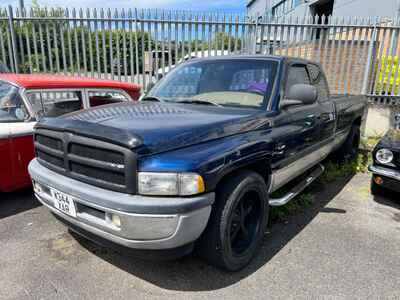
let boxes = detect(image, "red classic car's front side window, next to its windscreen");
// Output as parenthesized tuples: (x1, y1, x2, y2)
(26, 90, 83, 117)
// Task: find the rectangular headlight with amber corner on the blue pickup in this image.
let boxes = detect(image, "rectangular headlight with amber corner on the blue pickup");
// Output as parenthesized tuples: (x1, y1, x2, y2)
(138, 172, 205, 196)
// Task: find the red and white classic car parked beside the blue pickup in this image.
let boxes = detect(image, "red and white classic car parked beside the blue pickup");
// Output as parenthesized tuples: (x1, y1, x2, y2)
(0, 74, 140, 192)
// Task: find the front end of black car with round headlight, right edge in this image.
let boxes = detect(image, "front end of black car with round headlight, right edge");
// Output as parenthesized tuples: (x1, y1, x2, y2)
(369, 129, 400, 195)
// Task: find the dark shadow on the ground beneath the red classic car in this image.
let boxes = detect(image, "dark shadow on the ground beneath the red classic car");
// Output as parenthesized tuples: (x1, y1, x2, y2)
(0, 188, 41, 219)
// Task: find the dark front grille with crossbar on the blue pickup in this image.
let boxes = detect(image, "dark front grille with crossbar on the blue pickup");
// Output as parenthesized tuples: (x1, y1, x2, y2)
(34, 129, 136, 194)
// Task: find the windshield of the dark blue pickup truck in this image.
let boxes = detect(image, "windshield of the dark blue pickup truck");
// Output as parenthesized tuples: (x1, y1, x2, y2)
(147, 59, 278, 108)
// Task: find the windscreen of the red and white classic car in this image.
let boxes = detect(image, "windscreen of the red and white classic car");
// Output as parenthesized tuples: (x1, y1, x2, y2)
(0, 83, 29, 122)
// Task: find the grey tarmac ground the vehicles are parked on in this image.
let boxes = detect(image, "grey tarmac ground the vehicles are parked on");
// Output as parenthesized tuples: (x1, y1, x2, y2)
(0, 174, 400, 299)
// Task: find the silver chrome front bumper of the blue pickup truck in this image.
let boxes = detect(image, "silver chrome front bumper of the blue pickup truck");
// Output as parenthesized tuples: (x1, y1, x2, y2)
(28, 159, 215, 250)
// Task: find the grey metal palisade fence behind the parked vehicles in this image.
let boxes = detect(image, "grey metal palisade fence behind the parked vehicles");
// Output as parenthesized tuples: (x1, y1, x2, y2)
(0, 6, 400, 105)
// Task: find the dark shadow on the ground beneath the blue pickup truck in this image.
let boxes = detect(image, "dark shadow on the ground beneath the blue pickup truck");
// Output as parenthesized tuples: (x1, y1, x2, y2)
(74, 172, 352, 291)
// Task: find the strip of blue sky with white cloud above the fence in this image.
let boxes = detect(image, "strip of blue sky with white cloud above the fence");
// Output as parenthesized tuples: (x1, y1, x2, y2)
(0, 0, 246, 13)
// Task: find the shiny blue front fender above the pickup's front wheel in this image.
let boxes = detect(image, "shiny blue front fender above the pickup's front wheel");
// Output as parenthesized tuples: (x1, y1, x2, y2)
(138, 130, 273, 191)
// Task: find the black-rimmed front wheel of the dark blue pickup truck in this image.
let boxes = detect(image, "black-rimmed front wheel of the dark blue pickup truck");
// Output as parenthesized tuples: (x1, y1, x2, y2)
(197, 171, 269, 271)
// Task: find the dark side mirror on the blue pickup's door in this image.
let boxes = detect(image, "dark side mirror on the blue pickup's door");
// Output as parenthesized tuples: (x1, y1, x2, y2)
(280, 84, 318, 108)
